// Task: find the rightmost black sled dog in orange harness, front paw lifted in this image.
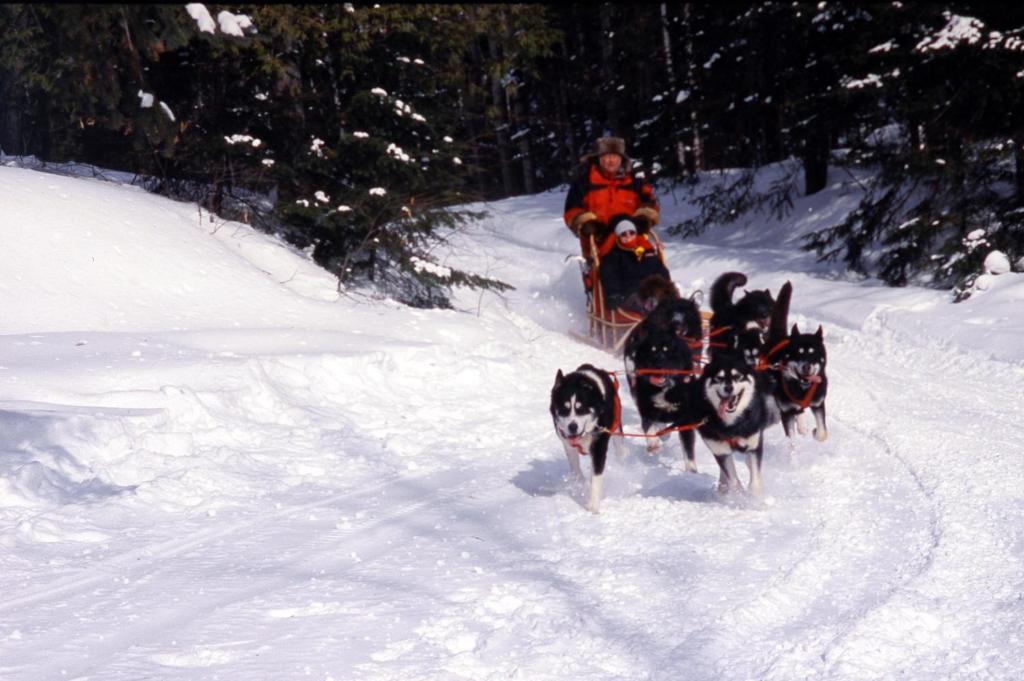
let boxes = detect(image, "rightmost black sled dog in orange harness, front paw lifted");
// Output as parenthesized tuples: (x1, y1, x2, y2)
(772, 325, 828, 442)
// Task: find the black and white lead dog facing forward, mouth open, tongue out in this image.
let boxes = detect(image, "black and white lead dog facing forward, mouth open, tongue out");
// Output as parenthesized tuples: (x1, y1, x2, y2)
(697, 351, 771, 496)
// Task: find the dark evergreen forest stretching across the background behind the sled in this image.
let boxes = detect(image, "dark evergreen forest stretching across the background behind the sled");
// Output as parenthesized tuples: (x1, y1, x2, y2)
(0, 2, 1024, 305)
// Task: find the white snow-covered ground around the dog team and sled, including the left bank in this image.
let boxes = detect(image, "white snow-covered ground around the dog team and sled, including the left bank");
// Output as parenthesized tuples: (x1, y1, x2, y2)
(0, 167, 1024, 681)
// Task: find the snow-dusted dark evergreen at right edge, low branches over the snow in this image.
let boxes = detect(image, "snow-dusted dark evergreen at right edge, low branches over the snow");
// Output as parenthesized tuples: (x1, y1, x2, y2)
(808, 6, 1024, 295)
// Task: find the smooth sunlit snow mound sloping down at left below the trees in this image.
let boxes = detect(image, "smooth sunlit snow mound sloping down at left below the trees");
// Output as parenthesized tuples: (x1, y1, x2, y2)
(0, 167, 338, 333)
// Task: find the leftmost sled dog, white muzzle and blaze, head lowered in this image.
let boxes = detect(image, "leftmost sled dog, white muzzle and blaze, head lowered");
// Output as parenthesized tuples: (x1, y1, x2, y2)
(551, 365, 622, 513)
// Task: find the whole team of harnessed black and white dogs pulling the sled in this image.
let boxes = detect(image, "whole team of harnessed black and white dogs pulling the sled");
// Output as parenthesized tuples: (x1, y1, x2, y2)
(550, 272, 828, 513)
